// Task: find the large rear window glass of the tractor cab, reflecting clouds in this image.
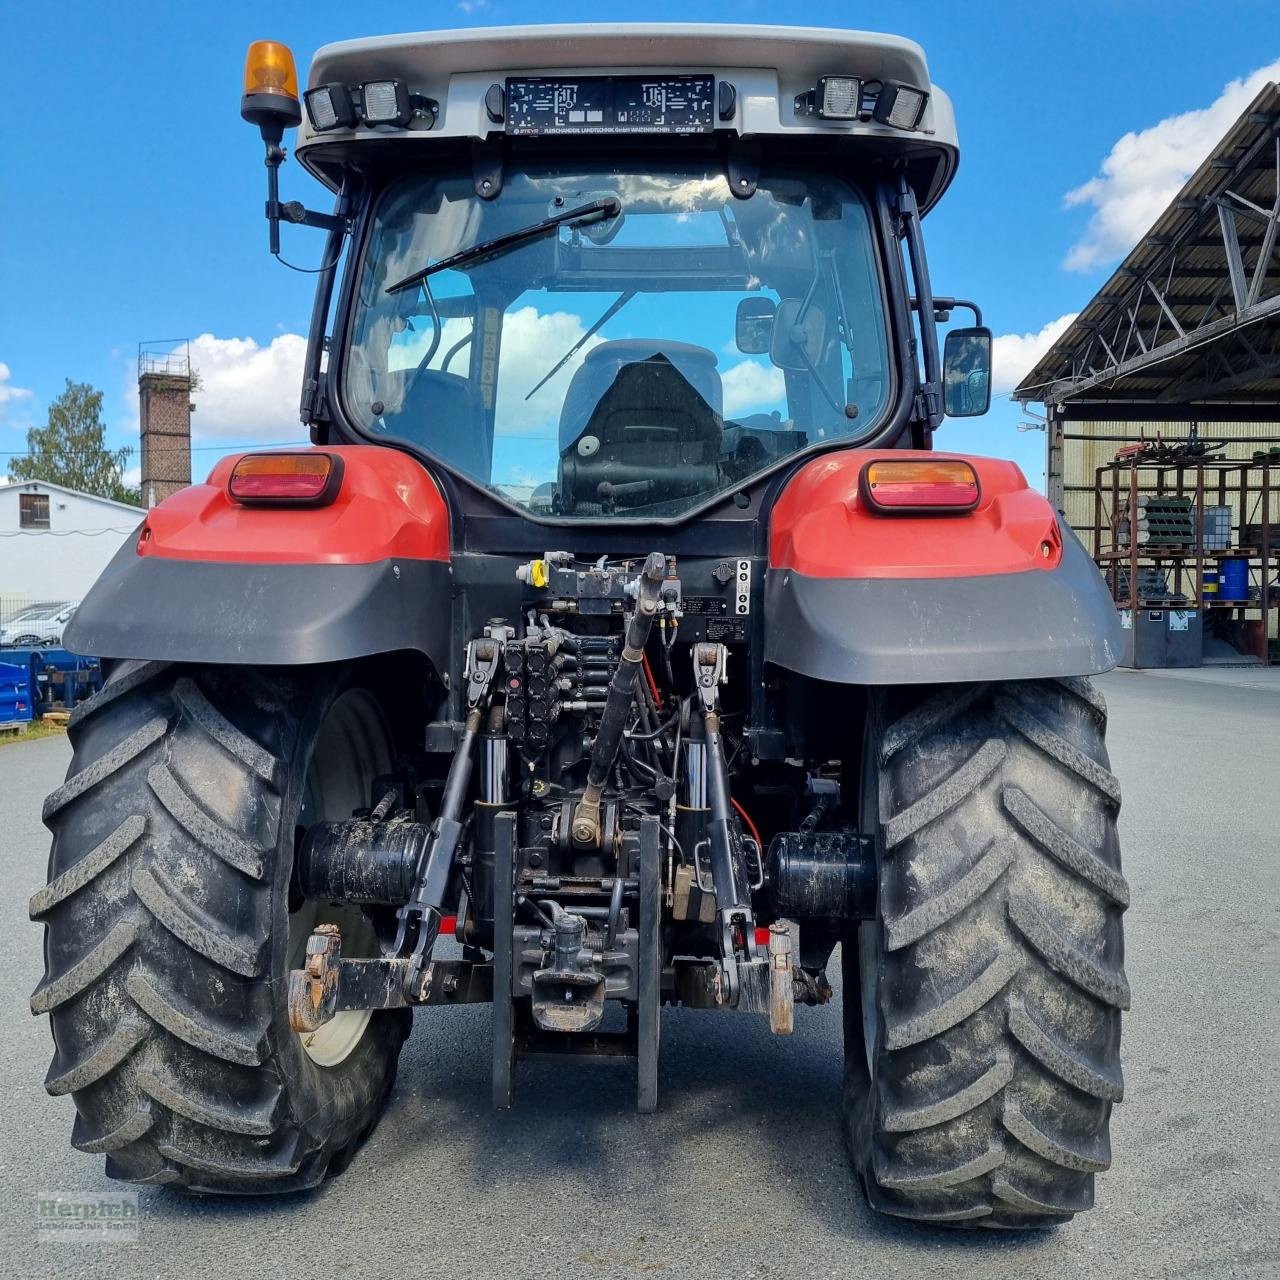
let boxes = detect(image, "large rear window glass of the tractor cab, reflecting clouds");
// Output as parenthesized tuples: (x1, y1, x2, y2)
(344, 168, 892, 520)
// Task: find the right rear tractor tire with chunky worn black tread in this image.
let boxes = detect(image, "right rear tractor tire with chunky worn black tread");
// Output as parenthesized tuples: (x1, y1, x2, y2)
(842, 680, 1129, 1228)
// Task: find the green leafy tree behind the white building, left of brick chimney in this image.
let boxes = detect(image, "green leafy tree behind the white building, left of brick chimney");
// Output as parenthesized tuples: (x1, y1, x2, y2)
(9, 378, 142, 506)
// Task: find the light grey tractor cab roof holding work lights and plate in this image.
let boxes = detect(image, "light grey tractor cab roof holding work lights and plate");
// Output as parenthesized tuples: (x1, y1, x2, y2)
(297, 23, 959, 209)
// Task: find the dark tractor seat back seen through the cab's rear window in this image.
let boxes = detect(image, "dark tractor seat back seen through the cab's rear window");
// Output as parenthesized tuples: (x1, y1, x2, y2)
(559, 338, 724, 509)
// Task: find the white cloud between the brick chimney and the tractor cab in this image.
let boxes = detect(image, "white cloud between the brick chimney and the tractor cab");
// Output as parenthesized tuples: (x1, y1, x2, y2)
(191, 333, 307, 440)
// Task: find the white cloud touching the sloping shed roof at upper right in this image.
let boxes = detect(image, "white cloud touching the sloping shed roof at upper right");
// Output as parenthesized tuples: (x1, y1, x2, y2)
(1062, 60, 1280, 271)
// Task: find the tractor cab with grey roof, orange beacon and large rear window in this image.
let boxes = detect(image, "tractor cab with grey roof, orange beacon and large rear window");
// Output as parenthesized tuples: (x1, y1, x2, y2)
(246, 26, 989, 522)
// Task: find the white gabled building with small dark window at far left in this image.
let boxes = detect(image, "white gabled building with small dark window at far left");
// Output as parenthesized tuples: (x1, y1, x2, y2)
(0, 480, 146, 617)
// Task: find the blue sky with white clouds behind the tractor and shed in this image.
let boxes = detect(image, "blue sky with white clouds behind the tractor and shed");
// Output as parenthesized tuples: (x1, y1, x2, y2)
(0, 0, 1280, 483)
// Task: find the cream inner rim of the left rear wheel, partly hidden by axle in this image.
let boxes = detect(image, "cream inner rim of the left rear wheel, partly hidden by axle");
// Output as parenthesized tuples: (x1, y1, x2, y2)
(288, 689, 392, 1068)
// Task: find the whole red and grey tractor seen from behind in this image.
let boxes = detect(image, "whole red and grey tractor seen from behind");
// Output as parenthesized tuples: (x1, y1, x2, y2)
(32, 26, 1129, 1226)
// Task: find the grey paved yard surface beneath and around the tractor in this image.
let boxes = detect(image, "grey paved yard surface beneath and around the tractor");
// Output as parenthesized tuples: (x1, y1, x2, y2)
(0, 672, 1280, 1280)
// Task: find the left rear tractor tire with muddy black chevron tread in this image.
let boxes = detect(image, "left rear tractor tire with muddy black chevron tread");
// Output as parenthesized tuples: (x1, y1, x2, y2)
(31, 662, 408, 1194)
